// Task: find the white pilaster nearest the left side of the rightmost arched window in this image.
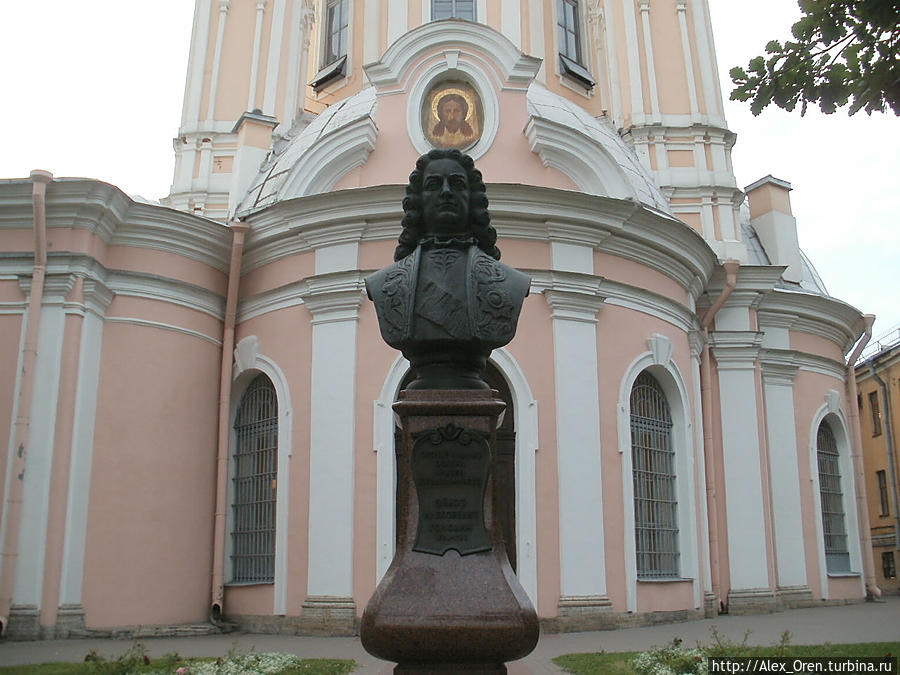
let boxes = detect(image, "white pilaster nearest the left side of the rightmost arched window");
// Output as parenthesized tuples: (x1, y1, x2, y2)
(761, 352, 807, 587)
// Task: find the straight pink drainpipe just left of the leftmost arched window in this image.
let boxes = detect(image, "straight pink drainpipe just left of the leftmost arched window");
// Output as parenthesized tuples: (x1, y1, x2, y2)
(210, 221, 250, 624)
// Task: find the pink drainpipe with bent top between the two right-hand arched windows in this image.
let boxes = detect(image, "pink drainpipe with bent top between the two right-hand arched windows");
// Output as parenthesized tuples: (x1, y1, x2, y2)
(700, 260, 740, 612)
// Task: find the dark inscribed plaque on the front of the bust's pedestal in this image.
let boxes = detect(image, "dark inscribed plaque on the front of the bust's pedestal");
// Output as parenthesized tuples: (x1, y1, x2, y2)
(412, 423, 491, 555)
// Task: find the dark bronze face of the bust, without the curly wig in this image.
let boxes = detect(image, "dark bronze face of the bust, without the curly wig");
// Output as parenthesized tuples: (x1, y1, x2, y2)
(422, 159, 469, 235)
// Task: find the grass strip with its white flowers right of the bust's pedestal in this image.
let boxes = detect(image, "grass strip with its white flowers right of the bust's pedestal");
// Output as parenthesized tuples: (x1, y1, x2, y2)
(553, 628, 900, 675)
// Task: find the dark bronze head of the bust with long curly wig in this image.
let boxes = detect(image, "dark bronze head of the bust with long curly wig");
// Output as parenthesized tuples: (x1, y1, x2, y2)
(394, 149, 500, 260)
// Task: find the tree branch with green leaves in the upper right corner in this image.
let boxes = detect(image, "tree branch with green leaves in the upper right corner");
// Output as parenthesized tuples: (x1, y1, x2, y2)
(729, 0, 900, 115)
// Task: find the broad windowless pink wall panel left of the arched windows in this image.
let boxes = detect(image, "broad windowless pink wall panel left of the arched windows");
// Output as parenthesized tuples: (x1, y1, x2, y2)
(84, 322, 220, 628)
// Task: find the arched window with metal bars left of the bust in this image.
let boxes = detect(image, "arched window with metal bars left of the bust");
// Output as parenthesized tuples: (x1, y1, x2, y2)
(231, 373, 278, 584)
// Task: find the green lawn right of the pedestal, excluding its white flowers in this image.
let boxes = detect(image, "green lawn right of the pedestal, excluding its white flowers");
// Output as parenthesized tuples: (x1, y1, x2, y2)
(553, 639, 900, 675)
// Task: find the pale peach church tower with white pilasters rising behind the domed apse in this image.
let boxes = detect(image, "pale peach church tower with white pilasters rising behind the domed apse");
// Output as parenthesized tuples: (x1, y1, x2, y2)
(166, 0, 746, 259)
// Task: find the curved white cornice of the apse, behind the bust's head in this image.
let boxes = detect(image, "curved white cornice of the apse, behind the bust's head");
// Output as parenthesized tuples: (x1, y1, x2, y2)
(243, 184, 716, 292)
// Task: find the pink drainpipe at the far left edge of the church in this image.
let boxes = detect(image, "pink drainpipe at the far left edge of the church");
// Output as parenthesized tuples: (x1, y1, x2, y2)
(0, 170, 53, 635)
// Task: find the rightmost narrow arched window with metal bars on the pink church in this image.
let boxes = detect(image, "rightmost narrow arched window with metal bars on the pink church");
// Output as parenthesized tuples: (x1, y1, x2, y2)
(816, 421, 850, 572)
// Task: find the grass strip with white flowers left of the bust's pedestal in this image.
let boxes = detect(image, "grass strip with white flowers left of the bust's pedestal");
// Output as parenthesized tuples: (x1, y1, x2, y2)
(0, 642, 357, 675)
